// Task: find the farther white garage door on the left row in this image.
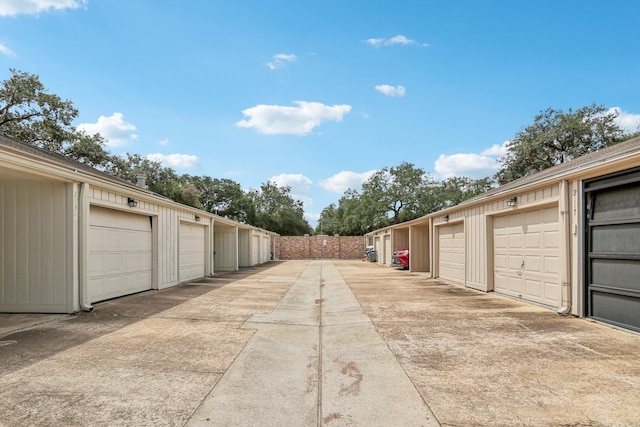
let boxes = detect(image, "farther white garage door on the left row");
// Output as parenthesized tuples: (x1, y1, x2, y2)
(178, 222, 206, 283)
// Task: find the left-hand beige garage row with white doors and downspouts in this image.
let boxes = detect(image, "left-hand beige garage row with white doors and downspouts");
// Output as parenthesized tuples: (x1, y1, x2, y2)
(0, 135, 274, 313)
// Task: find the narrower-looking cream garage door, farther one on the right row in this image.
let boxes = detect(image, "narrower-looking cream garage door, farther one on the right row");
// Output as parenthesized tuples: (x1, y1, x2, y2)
(438, 222, 465, 284)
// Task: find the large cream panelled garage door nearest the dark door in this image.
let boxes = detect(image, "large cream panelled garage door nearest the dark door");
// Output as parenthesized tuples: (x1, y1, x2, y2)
(493, 206, 560, 307)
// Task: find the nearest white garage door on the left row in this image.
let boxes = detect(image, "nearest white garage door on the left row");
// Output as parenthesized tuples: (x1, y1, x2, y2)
(88, 206, 152, 302)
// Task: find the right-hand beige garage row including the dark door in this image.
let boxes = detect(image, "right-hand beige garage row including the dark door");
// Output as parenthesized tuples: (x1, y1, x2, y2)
(365, 138, 640, 331)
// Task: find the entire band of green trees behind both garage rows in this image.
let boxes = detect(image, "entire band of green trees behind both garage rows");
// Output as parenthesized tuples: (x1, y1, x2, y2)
(8, 69, 638, 239)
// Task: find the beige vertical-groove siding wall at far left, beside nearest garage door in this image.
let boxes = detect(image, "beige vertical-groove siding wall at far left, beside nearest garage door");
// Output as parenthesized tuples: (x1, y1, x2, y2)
(0, 176, 75, 313)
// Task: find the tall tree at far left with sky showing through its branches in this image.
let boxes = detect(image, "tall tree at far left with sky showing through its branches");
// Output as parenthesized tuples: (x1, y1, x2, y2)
(0, 69, 109, 167)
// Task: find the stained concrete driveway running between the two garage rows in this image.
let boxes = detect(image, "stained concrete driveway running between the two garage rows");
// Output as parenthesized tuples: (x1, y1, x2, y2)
(0, 260, 640, 427)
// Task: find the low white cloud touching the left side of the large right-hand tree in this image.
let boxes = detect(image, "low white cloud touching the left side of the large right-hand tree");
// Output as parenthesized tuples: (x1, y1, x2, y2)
(434, 141, 508, 179)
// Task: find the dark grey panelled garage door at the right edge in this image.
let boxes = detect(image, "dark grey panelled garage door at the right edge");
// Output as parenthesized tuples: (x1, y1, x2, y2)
(585, 170, 640, 331)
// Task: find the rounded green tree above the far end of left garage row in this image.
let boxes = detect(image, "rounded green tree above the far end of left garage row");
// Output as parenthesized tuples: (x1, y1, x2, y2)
(249, 181, 312, 236)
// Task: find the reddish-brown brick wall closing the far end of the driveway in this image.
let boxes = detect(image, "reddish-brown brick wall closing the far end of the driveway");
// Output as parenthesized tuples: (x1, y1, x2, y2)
(275, 234, 364, 259)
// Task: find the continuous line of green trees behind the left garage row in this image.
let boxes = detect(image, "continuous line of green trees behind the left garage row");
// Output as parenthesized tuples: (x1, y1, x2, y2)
(0, 69, 311, 234)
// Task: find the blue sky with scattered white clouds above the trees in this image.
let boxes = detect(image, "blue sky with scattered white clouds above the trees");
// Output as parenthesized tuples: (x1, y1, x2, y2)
(0, 0, 640, 226)
